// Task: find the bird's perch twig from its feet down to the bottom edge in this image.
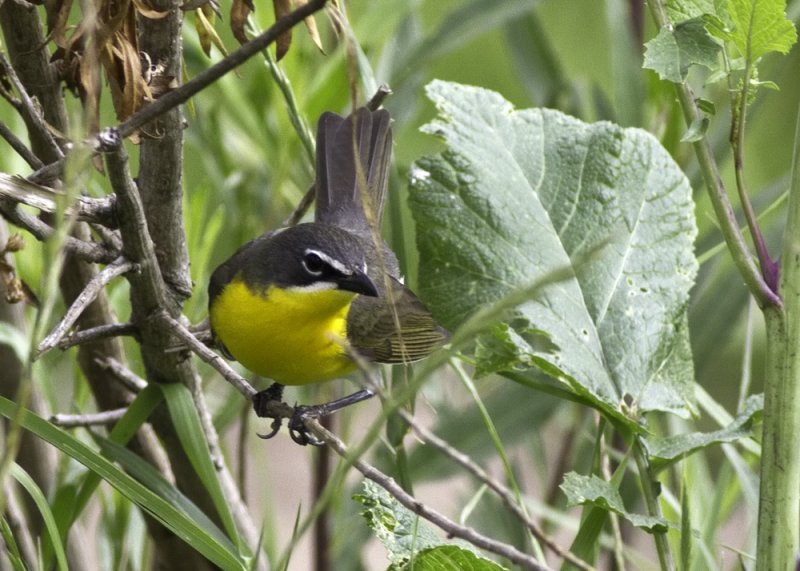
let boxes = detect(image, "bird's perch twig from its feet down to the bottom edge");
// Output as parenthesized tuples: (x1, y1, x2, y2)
(305, 418, 549, 571)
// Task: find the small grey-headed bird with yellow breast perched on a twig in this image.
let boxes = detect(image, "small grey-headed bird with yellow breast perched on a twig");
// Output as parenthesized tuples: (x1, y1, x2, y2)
(208, 107, 449, 444)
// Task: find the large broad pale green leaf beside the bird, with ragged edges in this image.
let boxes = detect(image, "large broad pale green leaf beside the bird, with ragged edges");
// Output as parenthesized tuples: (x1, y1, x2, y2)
(411, 82, 697, 424)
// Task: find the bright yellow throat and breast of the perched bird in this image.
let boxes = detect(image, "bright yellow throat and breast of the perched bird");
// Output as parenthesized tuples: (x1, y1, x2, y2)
(210, 276, 356, 385)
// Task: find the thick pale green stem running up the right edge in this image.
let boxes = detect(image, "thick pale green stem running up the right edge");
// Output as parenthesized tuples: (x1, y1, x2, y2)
(756, 104, 800, 571)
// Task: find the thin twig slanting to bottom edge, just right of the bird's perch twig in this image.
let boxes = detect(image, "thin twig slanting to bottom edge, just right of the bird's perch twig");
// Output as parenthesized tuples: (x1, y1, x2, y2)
(398, 409, 594, 571)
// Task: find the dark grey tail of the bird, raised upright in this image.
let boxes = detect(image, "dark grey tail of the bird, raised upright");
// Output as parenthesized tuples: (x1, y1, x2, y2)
(316, 107, 392, 234)
